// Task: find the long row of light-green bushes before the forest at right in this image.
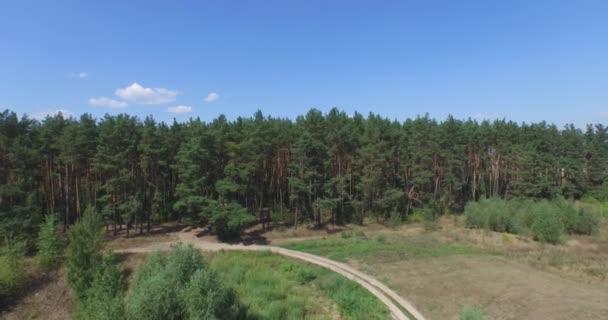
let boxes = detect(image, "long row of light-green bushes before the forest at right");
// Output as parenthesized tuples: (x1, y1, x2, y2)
(465, 198, 599, 244)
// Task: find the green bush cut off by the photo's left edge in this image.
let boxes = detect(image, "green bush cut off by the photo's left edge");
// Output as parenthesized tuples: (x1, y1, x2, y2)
(0, 237, 26, 305)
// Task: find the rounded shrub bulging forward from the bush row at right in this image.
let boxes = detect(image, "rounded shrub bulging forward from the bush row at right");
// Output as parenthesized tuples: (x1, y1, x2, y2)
(532, 201, 563, 244)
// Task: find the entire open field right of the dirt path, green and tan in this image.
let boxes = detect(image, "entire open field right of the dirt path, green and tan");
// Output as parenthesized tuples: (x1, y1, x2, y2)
(281, 218, 608, 320)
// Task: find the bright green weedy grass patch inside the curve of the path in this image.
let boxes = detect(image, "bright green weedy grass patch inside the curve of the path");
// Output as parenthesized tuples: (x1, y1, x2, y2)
(210, 252, 390, 320)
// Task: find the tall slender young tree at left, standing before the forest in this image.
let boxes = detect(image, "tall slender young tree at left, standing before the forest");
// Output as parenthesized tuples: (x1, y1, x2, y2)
(66, 208, 105, 298)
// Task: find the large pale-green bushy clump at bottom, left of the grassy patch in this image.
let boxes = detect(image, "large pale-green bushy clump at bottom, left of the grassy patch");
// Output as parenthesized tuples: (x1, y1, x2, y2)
(126, 245, 243, 320)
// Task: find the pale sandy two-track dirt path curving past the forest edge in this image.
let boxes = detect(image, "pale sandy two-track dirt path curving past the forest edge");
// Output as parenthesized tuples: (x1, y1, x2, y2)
(115, 230, 425, 320)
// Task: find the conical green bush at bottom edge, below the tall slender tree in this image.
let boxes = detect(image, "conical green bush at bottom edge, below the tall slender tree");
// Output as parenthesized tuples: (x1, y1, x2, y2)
(74, 252, 126, 320)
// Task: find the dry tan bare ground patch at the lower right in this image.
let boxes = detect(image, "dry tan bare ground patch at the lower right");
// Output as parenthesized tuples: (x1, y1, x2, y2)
(360, 256, 608, 320)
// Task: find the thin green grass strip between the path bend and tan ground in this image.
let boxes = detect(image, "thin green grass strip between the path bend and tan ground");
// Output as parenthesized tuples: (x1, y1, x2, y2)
(282, 234, 498, 263)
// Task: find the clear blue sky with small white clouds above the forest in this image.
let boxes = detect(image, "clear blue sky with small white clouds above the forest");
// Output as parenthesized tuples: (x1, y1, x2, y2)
(0, 0, 608, 126)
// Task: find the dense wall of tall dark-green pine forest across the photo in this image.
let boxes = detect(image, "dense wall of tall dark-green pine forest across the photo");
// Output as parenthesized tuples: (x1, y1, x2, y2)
(0, 109, 608, 240)
